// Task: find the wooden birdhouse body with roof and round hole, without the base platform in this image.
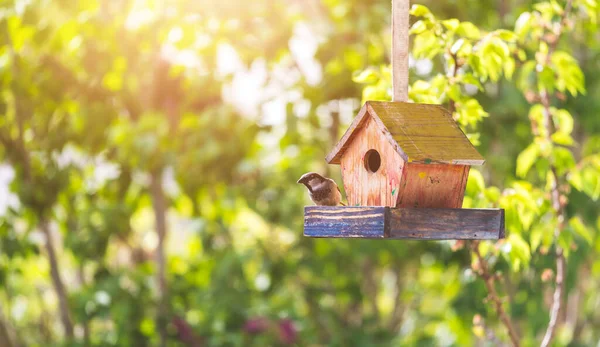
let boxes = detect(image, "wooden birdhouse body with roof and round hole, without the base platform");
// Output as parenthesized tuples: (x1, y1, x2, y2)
(326, 101, 484, 208)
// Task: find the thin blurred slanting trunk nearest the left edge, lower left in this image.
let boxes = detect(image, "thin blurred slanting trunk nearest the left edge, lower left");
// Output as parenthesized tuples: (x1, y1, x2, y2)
(40, 219, 73, 339)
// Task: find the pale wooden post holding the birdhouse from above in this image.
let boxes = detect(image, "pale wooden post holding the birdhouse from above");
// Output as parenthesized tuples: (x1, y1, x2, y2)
(392, 0, 410, 102)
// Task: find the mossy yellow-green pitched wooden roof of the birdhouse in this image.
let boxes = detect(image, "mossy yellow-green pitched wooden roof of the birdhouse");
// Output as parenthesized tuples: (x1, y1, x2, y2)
(325, 101, 485, 165)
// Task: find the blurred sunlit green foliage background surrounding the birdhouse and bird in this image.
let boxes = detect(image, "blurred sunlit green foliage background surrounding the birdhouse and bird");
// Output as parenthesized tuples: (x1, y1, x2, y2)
(0, 0, 600, 347)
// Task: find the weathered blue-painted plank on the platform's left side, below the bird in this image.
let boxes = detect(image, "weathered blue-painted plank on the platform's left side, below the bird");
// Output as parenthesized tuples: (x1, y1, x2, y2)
(304, 206, 387, 238)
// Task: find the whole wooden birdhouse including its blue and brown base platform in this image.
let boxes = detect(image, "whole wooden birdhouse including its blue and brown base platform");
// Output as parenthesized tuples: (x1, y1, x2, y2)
(304, 101, 504, 240)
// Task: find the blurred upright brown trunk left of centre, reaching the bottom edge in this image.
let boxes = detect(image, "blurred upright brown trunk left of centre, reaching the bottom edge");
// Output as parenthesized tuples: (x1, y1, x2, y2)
(150, 170, 169, 347)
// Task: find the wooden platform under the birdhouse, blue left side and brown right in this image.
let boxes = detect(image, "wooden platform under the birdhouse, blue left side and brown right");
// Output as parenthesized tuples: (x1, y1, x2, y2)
(304, 206, 504, 240)
